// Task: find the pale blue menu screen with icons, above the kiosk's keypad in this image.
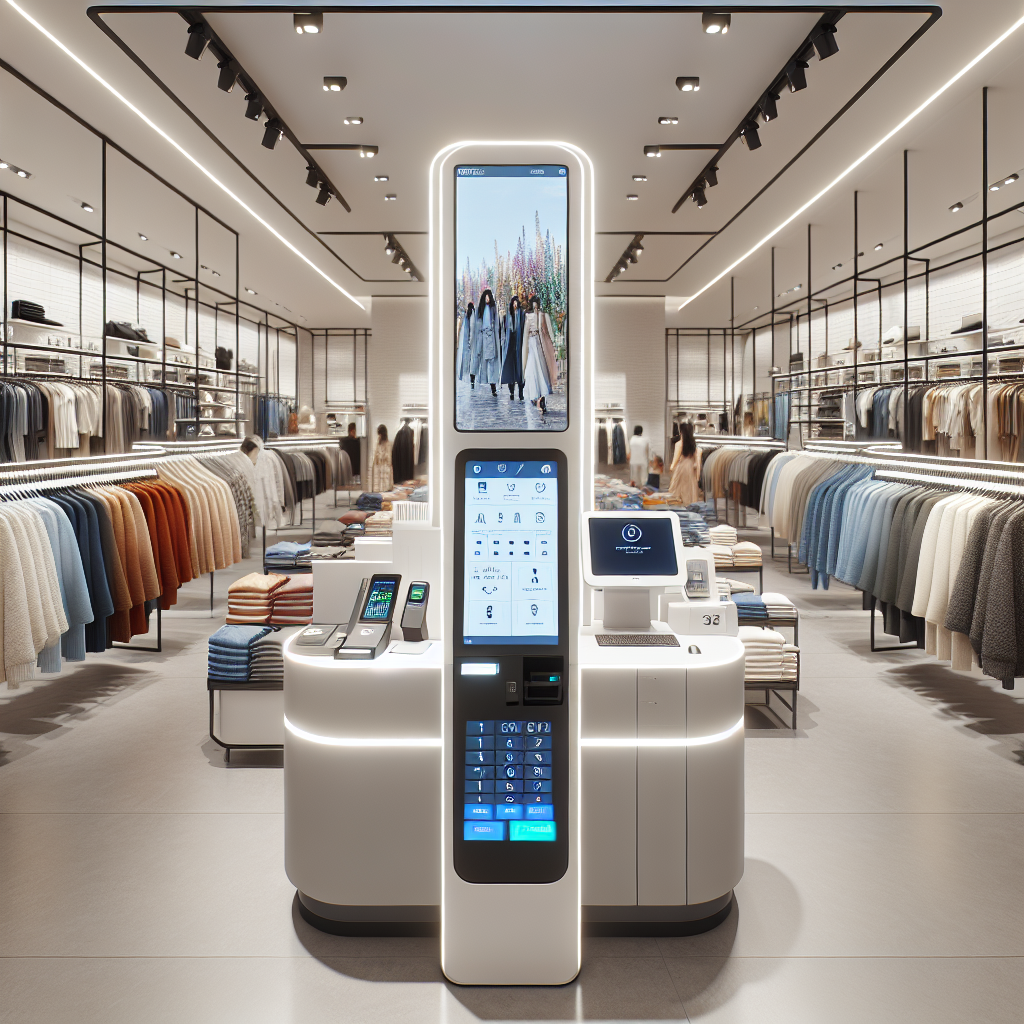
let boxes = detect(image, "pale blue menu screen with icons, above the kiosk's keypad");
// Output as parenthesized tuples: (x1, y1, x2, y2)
(462, 461, 558, 645)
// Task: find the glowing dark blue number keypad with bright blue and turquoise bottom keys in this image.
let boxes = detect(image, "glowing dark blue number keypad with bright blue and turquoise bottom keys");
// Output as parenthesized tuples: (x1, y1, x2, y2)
(463, 719, 558, 843)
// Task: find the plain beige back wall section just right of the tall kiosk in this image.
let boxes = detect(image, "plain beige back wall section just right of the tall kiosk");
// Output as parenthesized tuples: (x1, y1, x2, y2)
(594, 296, 665, 456)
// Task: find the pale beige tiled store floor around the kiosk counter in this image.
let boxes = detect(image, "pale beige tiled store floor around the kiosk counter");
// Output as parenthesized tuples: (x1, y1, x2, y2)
(0, 516, 1024, 1024)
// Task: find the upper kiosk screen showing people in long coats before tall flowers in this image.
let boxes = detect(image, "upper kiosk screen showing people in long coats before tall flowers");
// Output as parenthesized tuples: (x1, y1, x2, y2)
(454, 164, 568, 431)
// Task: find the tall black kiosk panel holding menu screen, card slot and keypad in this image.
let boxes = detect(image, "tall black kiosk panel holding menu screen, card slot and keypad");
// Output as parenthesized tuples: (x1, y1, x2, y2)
(453, 450, 569, 884)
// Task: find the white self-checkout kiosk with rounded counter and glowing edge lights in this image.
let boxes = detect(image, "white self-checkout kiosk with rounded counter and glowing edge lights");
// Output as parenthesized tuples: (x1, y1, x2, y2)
(285, 142, 743, 985)
